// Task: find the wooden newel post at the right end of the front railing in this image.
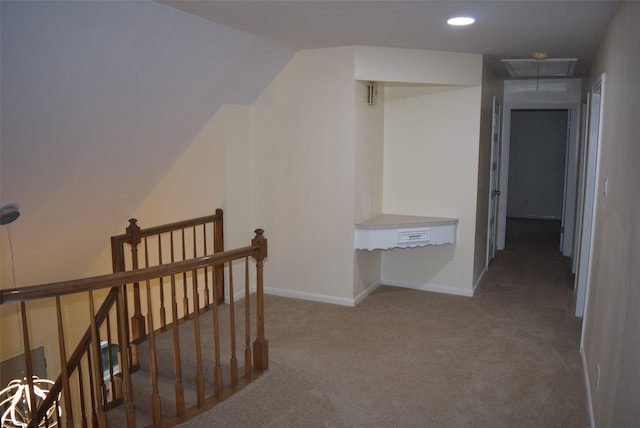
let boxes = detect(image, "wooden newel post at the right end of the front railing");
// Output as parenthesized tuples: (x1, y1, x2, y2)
(251, 229, 269, 372)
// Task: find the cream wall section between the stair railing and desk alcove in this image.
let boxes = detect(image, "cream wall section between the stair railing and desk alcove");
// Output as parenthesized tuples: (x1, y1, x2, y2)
(251, 47, 356, 304)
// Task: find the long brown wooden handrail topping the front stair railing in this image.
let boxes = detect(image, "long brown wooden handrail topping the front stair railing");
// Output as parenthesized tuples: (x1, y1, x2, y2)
(0, 245, 261, 304)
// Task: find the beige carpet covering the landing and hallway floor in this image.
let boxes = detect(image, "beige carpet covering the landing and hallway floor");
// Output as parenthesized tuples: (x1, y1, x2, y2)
(180, 221, 588, 428)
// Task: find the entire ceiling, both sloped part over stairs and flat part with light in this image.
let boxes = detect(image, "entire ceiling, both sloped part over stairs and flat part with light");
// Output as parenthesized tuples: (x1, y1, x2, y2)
(0, 0, 616, 288)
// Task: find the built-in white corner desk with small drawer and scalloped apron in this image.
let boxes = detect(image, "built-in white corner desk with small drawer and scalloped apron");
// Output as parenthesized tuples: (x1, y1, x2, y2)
(355, 214, 458, 250)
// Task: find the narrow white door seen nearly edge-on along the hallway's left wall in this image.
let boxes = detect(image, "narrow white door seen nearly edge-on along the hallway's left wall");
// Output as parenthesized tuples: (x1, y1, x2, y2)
(487, 97, 502, 265)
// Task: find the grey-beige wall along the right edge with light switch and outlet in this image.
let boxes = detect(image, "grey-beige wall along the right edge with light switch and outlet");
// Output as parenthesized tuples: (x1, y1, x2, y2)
(583, 2, 640, 427)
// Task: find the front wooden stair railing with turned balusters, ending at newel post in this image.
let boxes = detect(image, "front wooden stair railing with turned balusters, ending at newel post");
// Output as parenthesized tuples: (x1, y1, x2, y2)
(0, 213, 269, 427)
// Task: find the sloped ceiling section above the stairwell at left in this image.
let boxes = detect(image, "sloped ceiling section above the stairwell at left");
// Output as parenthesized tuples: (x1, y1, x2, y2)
(0, 0, 294, 288)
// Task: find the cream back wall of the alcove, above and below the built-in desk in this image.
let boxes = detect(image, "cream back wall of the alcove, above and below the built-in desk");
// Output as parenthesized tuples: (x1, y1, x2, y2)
(382, 86, 481, 295)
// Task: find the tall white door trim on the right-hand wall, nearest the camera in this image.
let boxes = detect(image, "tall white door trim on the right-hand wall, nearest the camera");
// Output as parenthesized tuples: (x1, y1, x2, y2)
(575, 74, 604, 322)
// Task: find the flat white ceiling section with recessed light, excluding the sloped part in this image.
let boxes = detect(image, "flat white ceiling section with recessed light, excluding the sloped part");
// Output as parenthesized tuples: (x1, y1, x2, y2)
(162, 0, 618, 76)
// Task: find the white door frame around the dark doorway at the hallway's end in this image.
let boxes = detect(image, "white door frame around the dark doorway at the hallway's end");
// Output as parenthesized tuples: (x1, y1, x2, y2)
(496, 101, 580, 256)
